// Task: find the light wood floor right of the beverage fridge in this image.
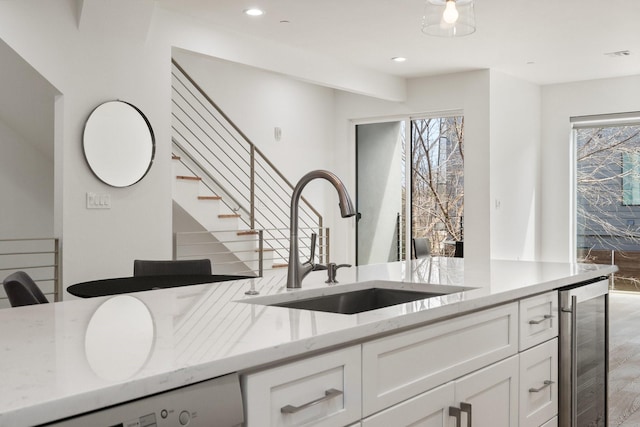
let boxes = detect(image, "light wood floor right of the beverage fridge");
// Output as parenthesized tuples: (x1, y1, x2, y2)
(609, 292, 640, 427)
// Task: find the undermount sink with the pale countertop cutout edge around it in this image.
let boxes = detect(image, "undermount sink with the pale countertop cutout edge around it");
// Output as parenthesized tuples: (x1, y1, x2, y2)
(242, 280, 472, 314)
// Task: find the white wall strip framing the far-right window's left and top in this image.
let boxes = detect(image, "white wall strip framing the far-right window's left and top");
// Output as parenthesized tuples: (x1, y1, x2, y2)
(541, 76, 640, 261)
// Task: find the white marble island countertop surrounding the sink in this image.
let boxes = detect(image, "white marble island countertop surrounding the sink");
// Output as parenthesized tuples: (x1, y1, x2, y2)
(0, 258, 616, 427)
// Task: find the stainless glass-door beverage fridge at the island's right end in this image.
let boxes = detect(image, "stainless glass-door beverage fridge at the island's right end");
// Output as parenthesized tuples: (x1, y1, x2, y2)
(558, 277, 609, 427)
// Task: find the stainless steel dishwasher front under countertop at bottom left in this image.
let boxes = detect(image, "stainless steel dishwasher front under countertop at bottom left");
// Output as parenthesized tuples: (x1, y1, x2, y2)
(46, 374, 244, 427)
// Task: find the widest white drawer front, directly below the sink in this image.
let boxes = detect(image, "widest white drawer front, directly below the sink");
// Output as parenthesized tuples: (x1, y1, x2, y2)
(362, 303, 518, 417)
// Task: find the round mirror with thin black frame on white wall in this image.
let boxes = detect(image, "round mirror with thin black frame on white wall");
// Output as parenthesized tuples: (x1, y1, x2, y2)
(82, 101, 155, 187)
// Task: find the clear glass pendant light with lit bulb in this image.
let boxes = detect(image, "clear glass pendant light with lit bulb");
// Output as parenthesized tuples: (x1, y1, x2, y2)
(422, 0, 476, 37)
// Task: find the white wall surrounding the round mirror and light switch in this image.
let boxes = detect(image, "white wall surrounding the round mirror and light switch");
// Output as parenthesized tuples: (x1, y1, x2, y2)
(0, 0, 171, 285)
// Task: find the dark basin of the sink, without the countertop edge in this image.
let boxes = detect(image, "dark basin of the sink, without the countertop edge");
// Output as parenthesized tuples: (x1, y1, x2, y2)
(270, 288, 445, 314)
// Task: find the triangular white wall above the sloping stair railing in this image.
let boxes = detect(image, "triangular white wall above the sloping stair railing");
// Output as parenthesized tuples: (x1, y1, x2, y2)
(173, 49, 337, 209)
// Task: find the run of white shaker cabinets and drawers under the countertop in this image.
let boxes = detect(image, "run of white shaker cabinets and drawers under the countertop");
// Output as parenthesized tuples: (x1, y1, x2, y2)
(242, 292, 558, 427)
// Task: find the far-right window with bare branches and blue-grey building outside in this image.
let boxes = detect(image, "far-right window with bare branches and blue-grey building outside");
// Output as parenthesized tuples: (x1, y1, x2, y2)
(573, 115, 640, 291)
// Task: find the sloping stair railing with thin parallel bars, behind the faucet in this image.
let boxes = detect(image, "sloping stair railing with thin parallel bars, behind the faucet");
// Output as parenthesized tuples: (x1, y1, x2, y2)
(172, 56, 329, 263)
